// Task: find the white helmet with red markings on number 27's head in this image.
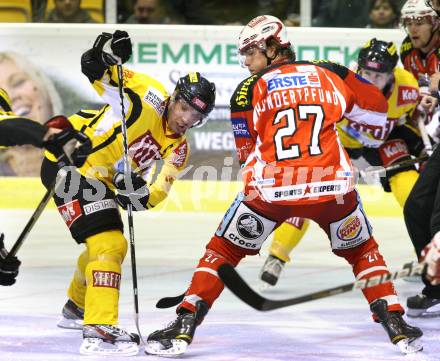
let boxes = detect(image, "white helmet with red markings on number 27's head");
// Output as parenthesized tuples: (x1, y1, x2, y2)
(238, 15, 291, 53)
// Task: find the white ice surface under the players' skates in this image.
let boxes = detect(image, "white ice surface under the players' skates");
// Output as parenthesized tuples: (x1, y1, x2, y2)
(0, 210, 440, 361)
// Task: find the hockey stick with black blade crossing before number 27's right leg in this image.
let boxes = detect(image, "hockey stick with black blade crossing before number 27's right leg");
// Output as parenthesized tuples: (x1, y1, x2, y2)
(218, 262, 425, 311)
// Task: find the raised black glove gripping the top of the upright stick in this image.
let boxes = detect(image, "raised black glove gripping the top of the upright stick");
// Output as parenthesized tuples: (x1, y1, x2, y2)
(93, 30, 132, 66)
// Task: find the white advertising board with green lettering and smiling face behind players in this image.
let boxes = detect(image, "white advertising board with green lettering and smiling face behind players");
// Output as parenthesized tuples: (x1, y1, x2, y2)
(0, 24, 405, 179)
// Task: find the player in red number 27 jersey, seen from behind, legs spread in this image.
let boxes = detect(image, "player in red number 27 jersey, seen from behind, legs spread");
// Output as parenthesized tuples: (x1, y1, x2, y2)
(146, 15, 422, 355)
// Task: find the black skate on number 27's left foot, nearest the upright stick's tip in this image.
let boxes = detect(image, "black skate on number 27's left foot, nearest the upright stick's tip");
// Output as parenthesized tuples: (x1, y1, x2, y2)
(145, 301, 209, 356)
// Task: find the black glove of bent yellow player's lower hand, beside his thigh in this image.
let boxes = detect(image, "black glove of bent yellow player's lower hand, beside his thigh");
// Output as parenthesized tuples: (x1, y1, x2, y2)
(113, 172, 150, 211)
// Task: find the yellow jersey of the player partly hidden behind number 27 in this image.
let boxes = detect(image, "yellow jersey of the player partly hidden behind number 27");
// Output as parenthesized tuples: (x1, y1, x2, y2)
(337, 68, 419, 148)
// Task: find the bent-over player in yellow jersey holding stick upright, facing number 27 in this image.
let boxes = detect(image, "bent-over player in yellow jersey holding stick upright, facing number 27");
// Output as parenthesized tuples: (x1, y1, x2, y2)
(43, 31, 215, 356)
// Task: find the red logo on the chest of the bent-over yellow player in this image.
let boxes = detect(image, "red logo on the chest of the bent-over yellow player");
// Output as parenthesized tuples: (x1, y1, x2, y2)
(128, 131, 162, 169)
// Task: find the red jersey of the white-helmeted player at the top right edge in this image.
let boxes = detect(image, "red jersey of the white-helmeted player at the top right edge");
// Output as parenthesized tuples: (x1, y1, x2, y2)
(400, 36, 440, 80)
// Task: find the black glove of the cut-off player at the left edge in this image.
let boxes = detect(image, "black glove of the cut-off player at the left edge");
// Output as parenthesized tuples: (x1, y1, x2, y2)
(43, 129, 92, 168)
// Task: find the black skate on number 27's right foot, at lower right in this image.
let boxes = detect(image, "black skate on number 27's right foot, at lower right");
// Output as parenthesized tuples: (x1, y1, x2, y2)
(370, 299, 423, 354)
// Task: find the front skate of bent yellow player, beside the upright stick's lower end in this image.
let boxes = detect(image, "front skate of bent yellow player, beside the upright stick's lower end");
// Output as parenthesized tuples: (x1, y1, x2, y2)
(79, 325, 140, 356)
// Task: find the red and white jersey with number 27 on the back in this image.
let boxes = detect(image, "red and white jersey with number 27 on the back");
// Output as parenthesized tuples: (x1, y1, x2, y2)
(231, 62, 388, 204)
